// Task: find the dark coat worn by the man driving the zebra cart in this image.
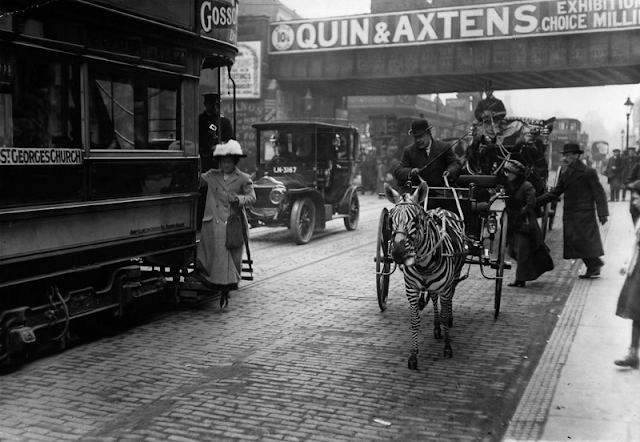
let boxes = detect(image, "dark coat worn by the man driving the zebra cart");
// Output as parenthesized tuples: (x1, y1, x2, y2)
(393, 138, 462, 191)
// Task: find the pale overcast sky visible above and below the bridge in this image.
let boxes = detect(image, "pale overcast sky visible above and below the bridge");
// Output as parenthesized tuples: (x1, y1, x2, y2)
(278, 0, 640, 147)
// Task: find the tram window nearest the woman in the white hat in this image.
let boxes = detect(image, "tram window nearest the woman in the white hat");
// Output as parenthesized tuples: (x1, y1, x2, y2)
(90, 72, 180, 150)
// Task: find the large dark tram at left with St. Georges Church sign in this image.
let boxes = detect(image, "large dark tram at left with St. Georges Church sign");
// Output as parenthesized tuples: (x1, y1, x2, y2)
(0, 0, 238, 366)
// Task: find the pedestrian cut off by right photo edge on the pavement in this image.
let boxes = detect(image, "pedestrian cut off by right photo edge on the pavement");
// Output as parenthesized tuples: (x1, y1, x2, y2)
(614, 180, 640, 368)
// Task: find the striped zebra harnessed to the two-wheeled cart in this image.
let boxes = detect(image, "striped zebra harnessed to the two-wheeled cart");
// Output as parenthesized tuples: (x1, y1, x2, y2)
(385, 182, 468, 370)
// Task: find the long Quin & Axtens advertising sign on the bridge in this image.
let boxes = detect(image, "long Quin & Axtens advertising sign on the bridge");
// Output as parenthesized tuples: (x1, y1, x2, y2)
(269, 0, 640, 54)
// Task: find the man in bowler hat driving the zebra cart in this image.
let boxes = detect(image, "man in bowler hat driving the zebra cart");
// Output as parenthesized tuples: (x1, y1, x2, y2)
(393, 118, 462, 193)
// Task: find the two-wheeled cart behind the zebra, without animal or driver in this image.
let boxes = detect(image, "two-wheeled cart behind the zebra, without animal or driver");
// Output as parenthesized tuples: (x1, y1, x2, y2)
(375, 175, 511, 319)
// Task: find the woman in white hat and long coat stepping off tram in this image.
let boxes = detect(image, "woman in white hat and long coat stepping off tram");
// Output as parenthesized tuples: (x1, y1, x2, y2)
(196, 140, 256, 307)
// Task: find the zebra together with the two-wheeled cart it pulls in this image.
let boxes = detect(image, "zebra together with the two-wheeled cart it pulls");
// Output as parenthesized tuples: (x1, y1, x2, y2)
(375, 175, 511, 369)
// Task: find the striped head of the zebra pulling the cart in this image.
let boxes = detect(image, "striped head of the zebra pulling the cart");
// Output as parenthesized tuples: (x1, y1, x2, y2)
(384, 182, 429, 266)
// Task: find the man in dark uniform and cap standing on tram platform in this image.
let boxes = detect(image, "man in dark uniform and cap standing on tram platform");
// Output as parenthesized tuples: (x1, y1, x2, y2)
(198, 92, 233, 172)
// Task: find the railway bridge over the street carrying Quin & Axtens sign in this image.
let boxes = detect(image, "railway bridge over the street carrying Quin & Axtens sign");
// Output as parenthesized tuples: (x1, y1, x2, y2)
(267, 0, 640, 96)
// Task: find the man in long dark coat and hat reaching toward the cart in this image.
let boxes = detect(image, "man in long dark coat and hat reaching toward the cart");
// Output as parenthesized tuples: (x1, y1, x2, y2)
(536, 143, 609, 278)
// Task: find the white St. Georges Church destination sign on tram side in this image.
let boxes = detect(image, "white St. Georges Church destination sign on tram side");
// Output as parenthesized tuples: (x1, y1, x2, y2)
(0, 147, 84, 166)
